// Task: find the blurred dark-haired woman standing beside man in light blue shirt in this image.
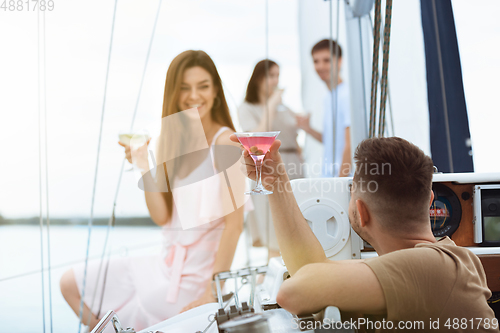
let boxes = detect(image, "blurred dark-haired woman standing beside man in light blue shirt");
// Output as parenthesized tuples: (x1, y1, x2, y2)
(238, 60, 303, 257)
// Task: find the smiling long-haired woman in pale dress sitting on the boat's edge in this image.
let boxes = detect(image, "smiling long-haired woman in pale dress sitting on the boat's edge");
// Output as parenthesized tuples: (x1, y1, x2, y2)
(61, 51, 244, 331)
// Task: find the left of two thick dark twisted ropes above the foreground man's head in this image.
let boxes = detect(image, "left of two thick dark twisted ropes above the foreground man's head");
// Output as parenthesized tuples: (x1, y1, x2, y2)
(368, 0, 381, 138)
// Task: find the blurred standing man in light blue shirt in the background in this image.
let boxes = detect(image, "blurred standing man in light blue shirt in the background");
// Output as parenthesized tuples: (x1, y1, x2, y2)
(297, 39, 351, 177)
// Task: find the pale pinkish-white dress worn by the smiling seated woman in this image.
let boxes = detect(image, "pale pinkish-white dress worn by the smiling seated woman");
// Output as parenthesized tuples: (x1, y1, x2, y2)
(73, 127, 233, 332)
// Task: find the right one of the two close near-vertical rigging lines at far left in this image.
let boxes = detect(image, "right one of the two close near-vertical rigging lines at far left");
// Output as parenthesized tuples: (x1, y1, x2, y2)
(42, 6, 53, 333)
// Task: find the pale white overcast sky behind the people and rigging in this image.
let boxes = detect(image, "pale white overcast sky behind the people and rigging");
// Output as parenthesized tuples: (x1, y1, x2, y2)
(0, 0, 500, 218)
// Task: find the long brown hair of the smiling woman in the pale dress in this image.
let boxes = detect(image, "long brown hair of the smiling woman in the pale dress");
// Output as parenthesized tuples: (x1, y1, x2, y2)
(157, 50, 235, 220)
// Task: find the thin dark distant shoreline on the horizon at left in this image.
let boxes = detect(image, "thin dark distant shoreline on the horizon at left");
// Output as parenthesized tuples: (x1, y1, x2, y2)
(0, 215, 155, 227)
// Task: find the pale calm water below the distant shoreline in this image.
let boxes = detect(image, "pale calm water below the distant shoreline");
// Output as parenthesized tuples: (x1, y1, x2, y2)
(0, 225, 266, 333)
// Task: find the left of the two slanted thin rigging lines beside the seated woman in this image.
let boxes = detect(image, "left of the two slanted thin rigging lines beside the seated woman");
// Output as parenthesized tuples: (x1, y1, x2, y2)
(78, 0, 118, 333)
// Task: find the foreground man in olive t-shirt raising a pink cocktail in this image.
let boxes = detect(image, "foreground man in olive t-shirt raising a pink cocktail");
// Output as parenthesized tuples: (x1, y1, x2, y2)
(232, 136, 498, 332)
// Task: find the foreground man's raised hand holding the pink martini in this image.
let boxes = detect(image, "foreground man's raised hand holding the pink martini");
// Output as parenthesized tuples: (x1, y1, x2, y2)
(229, 134, 286, 191)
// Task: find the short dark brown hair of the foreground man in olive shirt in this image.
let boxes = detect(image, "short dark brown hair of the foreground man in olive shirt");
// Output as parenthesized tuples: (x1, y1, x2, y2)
(353, 137, 434, 231)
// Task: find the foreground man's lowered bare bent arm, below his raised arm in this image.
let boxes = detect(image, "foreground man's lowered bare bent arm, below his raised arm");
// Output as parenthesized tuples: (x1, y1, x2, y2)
(276, 260, 387, 314)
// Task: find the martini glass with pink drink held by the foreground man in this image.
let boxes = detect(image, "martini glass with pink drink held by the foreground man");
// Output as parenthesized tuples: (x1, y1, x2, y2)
(235, 131, 280, 195)
